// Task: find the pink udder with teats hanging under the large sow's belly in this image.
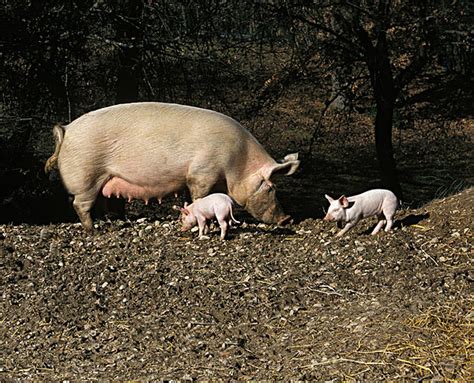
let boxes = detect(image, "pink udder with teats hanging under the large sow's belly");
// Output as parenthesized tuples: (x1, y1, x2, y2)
(102, 177, 179, 203)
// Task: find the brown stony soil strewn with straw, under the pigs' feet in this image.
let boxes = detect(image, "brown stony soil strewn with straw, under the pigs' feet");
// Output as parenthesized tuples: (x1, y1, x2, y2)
(0, 188, 474, 381)
